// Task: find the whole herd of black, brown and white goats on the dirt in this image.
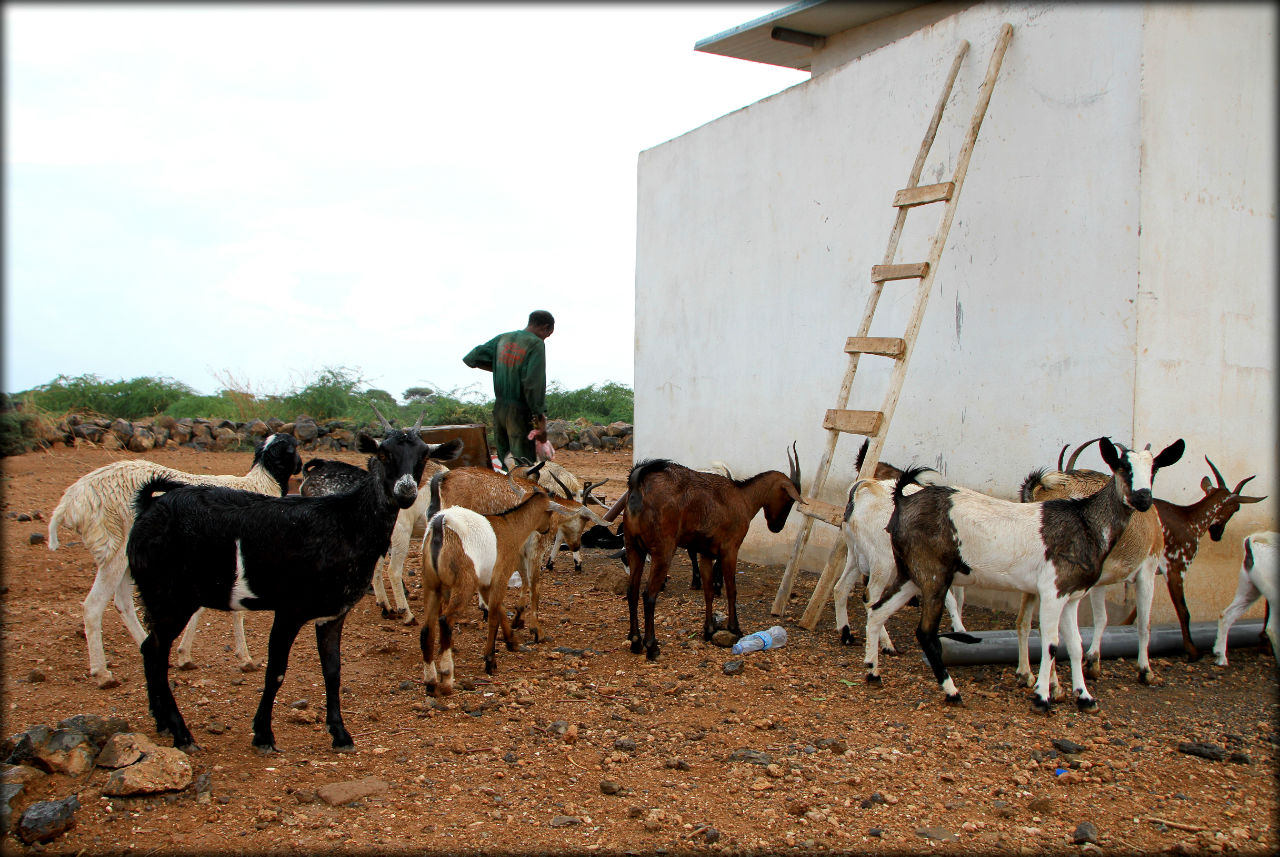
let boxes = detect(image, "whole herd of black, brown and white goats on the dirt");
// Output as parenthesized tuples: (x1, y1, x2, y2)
(49, 408, 1280, 752)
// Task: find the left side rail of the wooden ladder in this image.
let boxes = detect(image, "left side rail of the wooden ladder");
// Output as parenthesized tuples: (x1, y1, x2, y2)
(769, 40, 969, 617)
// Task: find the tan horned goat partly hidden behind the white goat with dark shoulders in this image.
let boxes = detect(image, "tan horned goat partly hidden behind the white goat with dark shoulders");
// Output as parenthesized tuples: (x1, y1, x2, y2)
(1016, 437, 1165, 689)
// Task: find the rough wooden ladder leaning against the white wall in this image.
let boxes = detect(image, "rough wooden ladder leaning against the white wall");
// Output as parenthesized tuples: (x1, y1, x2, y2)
(771, 23, 1014, 631)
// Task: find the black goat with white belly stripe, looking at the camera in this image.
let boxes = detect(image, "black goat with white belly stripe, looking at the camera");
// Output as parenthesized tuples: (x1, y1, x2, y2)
(128, 408, 461, 752)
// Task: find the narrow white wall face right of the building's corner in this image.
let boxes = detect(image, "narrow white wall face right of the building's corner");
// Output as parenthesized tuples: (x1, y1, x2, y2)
(1134, 4, 1277, 620)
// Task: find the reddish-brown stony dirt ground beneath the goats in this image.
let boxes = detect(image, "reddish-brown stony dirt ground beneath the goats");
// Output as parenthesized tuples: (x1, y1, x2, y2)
(0, 449, 1280, 854)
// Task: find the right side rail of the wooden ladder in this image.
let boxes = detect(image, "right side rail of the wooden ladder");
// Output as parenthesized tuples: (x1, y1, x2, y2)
(799, 23, 1014, 631)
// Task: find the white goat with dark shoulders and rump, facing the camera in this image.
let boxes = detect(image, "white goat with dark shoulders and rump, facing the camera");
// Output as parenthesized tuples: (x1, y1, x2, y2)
(885, 437, 1185, 711)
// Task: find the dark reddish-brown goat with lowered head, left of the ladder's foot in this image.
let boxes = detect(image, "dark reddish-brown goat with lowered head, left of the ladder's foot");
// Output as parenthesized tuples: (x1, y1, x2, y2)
(622, 444, 804, 660)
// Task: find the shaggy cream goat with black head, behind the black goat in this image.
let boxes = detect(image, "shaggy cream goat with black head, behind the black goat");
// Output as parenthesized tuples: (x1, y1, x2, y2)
(49, 435, 302, 688)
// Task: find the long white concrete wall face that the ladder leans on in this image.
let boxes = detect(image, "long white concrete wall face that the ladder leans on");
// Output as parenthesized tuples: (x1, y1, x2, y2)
(635, 4, 1274, 619)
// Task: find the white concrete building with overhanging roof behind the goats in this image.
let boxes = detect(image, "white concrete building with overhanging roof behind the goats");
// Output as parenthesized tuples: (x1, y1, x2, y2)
(635, 0, 1277, 622)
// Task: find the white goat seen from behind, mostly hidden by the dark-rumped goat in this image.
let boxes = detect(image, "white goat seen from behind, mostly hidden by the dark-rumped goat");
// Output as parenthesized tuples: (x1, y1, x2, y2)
(832, 473, 965, 657)
